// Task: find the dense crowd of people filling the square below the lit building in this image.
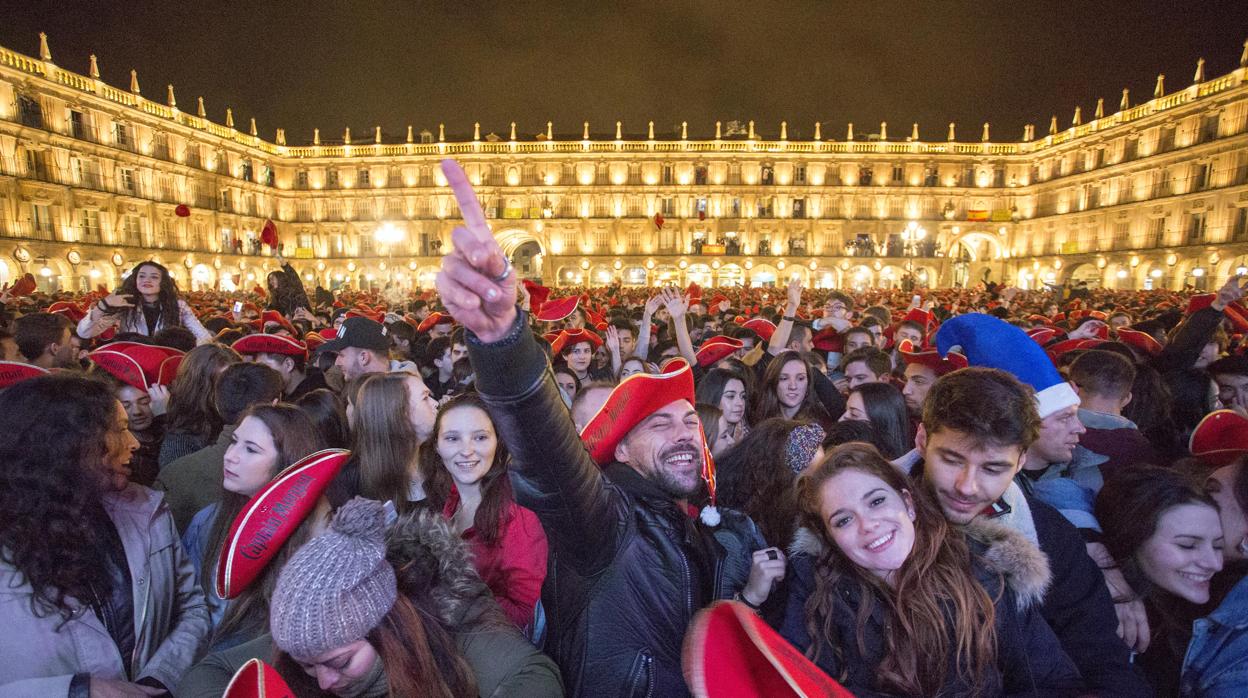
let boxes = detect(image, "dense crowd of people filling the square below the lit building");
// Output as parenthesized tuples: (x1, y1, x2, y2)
(0, 161, 1248, 698)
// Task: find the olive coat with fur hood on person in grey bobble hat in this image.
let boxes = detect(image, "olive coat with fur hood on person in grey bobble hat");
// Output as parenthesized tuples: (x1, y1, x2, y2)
(173, 512, 563, 698)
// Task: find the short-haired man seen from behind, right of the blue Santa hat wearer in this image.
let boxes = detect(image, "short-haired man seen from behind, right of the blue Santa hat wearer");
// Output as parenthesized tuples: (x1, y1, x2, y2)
(1070, 350, 1159, 477)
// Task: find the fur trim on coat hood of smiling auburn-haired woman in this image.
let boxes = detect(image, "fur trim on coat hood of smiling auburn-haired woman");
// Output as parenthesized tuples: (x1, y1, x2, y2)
(789, 517, 1053, 608)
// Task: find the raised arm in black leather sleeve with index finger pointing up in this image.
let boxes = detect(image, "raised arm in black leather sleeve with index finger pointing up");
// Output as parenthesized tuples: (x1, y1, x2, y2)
(437, 160, 628, 573)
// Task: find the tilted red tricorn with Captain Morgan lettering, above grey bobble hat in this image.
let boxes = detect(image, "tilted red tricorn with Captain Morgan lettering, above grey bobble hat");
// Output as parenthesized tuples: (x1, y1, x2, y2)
(216, 448, 351, 599)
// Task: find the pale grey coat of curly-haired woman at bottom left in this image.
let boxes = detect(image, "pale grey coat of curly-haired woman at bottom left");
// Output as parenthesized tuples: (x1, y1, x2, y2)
(0, 484, 208, 698)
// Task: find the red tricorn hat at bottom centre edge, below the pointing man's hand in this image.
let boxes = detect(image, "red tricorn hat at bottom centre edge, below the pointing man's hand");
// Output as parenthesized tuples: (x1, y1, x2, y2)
(680, 601, 854, 698)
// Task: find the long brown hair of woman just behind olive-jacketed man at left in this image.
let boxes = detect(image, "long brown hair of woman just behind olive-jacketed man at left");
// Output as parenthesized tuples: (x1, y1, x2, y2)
(165, 343, 242, 441)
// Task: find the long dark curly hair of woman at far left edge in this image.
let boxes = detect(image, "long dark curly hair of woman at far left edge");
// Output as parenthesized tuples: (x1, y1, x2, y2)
(0, 373, 117, 621)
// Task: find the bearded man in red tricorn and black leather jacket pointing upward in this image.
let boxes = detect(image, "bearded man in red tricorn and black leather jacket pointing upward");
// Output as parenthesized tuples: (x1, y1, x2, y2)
(437, 160, 784, 697)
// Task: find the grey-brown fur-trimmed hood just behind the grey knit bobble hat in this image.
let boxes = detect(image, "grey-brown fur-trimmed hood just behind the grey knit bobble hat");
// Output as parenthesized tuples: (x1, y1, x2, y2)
(386, 509, 497, 628)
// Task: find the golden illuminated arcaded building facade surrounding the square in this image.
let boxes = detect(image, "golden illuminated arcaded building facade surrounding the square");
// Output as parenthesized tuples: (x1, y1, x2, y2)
(0, 37, 1248, 290)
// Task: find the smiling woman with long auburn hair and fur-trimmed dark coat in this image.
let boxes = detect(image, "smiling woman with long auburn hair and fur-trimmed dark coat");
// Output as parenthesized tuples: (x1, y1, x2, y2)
(780, 443, 1081, 697)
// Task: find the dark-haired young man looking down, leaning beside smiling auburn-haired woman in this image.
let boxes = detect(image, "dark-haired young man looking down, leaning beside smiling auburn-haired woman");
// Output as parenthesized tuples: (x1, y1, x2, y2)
(897, 368, 1152, 697)
